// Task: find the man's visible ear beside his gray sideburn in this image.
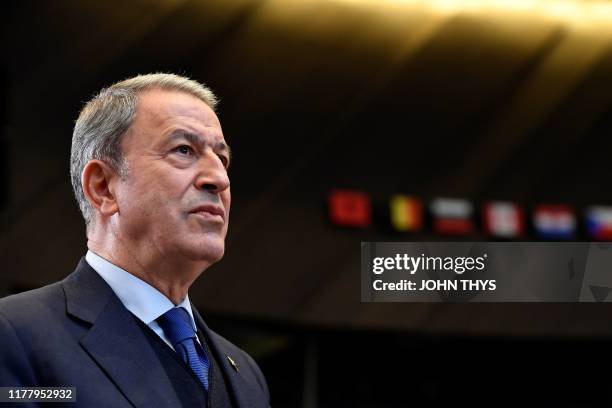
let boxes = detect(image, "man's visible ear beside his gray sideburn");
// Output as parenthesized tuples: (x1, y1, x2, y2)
(81, 160, 119, 217)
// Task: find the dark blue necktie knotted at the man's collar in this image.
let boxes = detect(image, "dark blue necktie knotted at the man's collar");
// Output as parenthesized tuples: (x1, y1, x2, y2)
(157, 307, 210, 391)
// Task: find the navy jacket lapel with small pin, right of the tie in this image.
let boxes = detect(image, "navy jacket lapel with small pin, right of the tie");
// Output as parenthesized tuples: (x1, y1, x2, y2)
(191, 304, 267, 408)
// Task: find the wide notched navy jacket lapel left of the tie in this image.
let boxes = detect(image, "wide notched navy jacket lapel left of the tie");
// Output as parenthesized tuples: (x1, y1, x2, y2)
(63, 259, 180, 407)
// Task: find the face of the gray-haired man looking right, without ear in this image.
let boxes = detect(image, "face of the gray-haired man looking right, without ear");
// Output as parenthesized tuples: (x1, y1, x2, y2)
(116, 90, 231, 263)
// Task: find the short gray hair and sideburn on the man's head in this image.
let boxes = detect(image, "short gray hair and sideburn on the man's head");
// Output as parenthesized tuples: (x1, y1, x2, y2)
(70, 73, 217, 230)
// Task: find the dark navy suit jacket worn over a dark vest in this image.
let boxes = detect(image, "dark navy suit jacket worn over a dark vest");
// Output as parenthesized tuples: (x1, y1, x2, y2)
(0, 258, 269, 408)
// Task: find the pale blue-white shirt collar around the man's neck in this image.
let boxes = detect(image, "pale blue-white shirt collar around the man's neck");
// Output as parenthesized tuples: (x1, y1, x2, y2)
(85, 251, 197, 331)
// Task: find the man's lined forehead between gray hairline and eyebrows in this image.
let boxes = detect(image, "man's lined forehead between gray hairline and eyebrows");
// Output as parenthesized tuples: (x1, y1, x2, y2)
(132, 89, 223, 140)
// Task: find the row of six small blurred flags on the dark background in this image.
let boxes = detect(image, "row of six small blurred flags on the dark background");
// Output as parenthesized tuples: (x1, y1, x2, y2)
(328, 190, 612, 241)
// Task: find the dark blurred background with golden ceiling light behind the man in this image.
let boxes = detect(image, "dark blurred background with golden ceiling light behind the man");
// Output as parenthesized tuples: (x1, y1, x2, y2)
(0, 0, 612, 408)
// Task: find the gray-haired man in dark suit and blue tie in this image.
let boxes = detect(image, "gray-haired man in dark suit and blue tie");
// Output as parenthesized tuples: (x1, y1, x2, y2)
(0, 74, 269, 408)
